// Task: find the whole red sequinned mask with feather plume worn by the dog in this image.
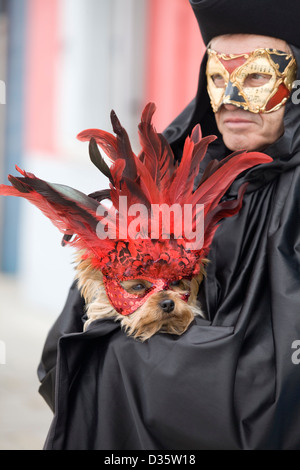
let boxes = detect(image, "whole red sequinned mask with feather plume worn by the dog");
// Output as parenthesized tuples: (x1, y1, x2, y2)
(0, 103, 272, 315)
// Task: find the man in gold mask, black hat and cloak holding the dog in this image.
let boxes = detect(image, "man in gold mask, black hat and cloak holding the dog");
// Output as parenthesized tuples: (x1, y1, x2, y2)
(40, 0, 300, 450)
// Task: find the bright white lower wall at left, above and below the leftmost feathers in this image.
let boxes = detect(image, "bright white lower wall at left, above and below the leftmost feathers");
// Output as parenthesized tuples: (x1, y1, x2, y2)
(19, 151, 108, 314)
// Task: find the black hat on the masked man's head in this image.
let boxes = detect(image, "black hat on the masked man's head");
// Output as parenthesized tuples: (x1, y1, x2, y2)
(190, 0, 300, 47)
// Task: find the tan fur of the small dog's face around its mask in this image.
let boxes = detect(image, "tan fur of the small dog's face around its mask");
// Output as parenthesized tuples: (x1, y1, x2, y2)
(77, 259, 205, 341)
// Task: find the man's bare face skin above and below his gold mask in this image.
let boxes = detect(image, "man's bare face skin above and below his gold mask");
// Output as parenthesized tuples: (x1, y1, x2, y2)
(210, 34, 290, 151)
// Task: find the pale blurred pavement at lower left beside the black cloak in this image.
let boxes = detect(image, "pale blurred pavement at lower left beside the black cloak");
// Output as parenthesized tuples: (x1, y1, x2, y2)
(0, 274, 54, 450)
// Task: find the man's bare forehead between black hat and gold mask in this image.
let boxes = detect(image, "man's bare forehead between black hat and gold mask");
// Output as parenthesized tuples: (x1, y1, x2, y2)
(209, 34, 291, 54)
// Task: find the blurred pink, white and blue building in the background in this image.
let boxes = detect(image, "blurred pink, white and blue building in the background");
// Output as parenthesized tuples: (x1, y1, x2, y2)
(0, 0, 204, 313)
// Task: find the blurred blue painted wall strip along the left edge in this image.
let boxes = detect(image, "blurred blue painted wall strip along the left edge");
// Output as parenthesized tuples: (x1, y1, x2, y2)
(0, 0, 26, 274)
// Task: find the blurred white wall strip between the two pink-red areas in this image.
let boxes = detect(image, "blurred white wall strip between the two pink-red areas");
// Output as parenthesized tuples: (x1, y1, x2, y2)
(56, 0, 147, 156)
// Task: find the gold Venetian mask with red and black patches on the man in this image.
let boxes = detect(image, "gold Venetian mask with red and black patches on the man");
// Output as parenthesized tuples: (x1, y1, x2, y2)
(206, 49, 297, 113)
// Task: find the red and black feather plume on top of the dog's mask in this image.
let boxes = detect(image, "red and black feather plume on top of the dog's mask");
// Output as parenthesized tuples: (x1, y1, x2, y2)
(0, 103, 272, 277)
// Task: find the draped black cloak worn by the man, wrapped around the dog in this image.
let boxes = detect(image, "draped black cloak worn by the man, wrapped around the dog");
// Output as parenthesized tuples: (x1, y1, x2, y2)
(39, 0, 300, 450)
